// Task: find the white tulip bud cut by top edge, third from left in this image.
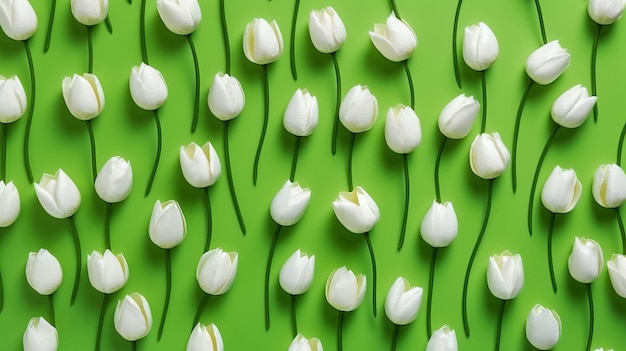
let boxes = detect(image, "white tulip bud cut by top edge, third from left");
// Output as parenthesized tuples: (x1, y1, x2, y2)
(157, 0, 202, 35)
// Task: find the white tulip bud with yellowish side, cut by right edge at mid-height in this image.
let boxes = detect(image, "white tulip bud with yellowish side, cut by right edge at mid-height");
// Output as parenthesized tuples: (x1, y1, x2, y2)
(592, 163, 626, 208)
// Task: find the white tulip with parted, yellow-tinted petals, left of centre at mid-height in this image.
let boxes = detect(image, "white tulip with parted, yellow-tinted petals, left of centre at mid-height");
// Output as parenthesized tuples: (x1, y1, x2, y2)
(180, 141, 222, 188)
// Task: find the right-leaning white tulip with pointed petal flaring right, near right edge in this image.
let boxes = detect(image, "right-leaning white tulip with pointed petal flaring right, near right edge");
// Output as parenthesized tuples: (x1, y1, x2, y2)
(550, 84, 598, 128)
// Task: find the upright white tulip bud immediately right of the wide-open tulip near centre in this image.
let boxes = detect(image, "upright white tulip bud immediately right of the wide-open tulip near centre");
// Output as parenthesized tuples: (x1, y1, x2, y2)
(420, 200, 459, 247)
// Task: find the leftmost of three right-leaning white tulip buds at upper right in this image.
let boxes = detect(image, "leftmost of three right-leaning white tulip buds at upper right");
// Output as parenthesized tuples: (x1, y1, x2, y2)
(437, 94, 480, 139)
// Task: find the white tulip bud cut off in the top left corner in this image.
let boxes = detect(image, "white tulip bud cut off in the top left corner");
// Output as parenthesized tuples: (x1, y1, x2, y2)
(0, 0, 37, 40)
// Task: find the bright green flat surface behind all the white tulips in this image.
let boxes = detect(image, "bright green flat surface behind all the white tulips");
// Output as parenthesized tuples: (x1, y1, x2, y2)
(0, 0, 626, 350)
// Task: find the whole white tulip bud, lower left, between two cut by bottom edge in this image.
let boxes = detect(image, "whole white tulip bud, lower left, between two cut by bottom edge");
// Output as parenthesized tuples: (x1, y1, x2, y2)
(113, 292, 152, 341)
